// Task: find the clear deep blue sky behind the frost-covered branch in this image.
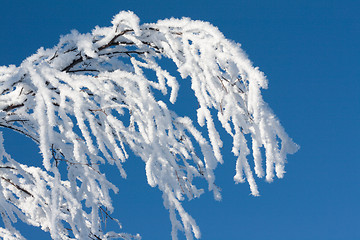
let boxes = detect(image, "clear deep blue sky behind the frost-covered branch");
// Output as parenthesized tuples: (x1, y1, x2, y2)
(0, 0, 360, 240)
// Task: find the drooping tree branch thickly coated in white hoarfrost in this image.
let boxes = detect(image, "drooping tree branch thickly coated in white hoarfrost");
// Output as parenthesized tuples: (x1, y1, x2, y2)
(0, 11, 298, 239)
